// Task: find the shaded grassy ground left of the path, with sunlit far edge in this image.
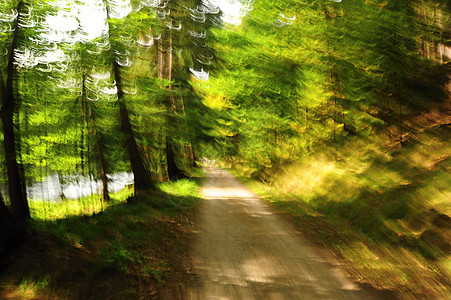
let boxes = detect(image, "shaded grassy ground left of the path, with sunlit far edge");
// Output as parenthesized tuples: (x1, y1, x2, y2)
(0, 179, 199, 299)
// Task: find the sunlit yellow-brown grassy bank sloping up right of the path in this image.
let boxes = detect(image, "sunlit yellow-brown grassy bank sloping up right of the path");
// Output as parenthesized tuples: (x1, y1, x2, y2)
(233, 128, 451, 299)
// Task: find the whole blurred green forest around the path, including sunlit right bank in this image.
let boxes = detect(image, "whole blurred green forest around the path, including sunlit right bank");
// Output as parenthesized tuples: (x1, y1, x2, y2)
(0, 0, 451, 298)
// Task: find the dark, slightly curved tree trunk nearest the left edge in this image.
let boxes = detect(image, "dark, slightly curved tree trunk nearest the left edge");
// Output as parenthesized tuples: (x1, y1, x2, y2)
(0, 1, 30, 223)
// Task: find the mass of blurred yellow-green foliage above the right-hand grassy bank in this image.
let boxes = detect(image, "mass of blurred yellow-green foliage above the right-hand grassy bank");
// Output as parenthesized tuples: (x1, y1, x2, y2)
(202, 1, 448, 181)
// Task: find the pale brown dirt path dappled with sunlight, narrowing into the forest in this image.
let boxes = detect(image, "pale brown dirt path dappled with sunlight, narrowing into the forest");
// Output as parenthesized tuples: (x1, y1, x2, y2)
(183, 167, 386, 300)
